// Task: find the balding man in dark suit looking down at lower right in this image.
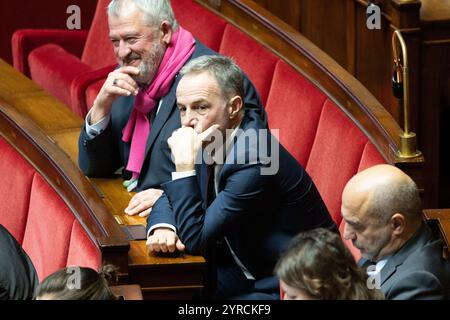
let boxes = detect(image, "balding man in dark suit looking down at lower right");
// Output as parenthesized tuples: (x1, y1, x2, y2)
(342, 165, 450, 300)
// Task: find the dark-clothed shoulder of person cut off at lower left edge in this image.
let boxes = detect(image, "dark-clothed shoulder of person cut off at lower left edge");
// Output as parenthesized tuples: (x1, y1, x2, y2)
(0, 224, 39, 300)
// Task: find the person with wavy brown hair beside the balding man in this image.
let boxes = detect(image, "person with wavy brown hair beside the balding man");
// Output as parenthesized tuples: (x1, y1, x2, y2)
(275, 228, 383, 300)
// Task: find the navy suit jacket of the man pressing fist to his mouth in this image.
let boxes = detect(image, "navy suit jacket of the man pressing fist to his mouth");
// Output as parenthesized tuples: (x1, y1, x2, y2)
(147, 115, 336, 296)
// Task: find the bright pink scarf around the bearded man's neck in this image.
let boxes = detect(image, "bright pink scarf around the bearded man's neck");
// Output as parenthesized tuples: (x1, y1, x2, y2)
(122, 27, 195, 179)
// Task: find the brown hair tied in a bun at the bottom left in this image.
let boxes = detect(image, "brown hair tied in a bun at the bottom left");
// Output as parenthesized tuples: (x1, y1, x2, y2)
(35, 265, 118, 300)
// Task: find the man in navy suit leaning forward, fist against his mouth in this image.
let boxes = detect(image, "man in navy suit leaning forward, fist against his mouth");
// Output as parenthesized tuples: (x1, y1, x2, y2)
(147, 56, 336, 299)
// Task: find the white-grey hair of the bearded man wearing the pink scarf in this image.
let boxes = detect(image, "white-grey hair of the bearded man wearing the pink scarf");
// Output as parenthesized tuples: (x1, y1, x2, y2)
(107, 0, 178, 30)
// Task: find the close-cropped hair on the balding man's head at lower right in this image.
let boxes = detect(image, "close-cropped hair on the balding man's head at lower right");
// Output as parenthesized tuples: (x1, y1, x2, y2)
(369, 179, 422, 222)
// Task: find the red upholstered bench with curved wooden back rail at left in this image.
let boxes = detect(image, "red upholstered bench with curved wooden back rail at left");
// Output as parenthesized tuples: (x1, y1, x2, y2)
(0, 97, 129, 280)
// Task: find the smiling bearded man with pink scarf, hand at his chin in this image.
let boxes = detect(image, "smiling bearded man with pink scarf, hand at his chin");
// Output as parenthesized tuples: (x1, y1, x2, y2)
(78, 0, 267, 217)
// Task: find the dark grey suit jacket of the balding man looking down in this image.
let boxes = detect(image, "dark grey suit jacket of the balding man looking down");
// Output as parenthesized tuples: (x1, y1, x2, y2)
(360, 224, 450, 300)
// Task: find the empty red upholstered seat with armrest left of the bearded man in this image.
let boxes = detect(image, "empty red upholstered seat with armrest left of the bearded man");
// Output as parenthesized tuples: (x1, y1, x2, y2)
(12, 0, 116, 117)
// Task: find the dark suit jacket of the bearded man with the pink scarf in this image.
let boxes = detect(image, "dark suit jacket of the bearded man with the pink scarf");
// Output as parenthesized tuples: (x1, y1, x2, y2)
(78, 41, 267, 191)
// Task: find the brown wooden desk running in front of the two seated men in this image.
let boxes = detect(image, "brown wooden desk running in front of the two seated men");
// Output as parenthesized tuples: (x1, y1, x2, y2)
(0, 59, 205, 299)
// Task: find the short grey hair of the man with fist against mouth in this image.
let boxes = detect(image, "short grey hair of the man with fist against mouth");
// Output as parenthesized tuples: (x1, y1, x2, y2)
(180, 55, 244, 100)
